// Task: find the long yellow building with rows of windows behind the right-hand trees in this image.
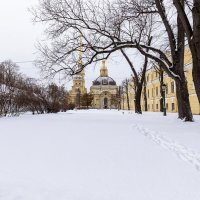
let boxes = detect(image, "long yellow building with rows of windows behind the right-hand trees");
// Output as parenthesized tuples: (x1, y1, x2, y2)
(122, 49, 200, 115)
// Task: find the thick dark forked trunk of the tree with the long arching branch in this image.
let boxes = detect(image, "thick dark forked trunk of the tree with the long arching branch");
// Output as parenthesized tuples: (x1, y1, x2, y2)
(155, 0, 192, 121)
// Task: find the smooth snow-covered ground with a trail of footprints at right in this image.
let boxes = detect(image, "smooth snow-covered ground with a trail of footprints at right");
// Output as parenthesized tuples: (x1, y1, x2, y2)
(0, 110, 200, 200)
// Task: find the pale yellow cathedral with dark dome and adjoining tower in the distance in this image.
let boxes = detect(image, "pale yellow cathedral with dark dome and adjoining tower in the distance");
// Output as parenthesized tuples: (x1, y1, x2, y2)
(69, 60, 118, 109)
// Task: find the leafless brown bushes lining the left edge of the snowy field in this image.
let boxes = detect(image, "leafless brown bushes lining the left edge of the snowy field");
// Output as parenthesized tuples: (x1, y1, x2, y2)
(0, 61, 71, 116)
